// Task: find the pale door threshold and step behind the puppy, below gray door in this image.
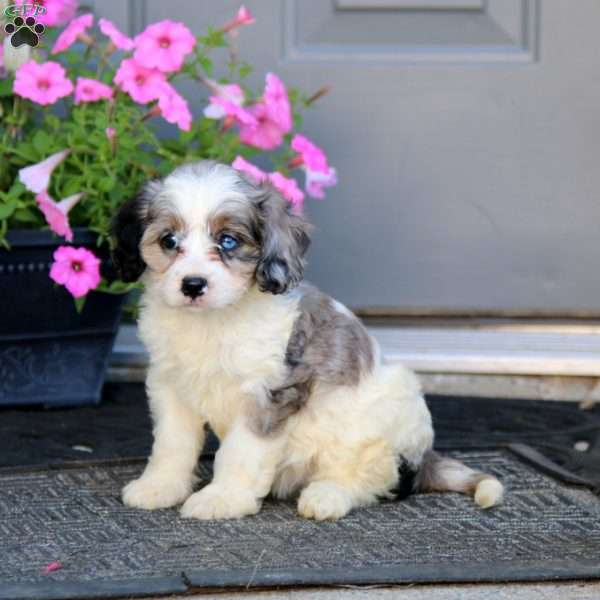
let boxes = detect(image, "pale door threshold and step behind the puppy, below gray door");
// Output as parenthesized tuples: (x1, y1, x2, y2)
(109, 324, 600, 403)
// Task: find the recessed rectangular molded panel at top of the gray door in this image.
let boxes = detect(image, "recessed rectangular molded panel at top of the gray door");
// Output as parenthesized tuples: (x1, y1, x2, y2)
(284, 0, 539, 62)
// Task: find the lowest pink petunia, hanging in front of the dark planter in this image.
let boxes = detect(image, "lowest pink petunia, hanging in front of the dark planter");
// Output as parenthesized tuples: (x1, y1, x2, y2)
(50, 246, 100, 298)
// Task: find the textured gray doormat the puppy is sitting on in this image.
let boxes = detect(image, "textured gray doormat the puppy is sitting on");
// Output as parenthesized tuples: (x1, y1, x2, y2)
(0, 450, 600, 600)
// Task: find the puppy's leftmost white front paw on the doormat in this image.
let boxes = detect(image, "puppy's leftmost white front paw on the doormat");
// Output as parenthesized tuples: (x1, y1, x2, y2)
(122, 474, 193, 510)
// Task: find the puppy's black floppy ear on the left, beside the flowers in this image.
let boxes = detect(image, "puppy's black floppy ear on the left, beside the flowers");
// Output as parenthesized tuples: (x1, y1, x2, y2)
(112, 181, 160, 282)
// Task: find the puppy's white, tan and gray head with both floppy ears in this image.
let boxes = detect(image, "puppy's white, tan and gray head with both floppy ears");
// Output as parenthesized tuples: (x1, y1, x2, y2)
(113, 161, 310, 308)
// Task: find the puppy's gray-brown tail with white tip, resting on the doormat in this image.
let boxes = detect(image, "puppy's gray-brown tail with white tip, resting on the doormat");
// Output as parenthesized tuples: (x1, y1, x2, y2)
(415, 450, 504, 508)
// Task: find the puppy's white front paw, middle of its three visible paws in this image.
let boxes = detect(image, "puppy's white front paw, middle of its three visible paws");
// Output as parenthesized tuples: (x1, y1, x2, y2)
(181, 483, 261, 520)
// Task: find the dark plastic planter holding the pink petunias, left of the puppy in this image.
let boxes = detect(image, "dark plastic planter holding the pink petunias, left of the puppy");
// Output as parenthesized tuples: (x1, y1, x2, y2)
(0, 230, 123, 406)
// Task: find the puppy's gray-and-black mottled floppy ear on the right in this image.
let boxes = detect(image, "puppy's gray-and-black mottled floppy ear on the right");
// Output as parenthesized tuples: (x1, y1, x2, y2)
(256, 187, 311, 294)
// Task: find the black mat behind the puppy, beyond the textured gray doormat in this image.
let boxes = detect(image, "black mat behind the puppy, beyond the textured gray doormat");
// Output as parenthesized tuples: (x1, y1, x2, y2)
(0, 383, 600, 490)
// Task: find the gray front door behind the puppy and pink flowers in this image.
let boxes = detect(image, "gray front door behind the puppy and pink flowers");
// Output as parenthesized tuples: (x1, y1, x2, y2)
(96, 0, 600, 312)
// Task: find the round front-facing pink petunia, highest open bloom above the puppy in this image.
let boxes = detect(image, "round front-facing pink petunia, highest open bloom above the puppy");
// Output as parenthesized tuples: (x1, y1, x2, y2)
(133, 19, 196, 73)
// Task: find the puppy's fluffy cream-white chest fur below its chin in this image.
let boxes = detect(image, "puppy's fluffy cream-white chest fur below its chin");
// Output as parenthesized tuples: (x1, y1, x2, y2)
(139, 292, 298, 437)
